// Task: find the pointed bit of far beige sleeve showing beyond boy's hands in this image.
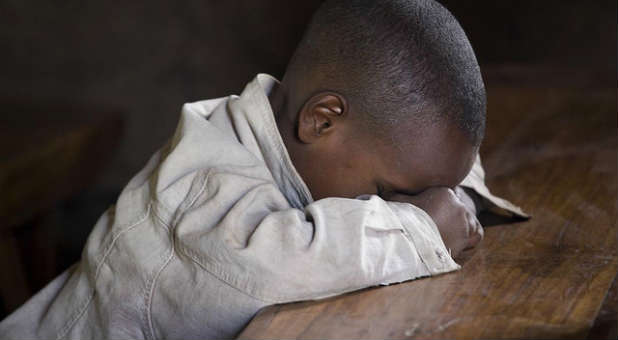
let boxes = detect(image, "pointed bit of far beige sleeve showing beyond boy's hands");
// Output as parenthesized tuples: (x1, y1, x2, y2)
(460, 154, 530, 218)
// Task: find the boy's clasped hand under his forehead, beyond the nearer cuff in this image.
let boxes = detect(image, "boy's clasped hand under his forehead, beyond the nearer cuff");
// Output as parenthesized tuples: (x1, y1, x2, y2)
(386, 188, 484, 257)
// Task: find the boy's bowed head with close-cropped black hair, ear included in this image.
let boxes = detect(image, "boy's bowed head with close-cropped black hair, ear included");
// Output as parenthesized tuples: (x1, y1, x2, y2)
(271, 0, 486, 199)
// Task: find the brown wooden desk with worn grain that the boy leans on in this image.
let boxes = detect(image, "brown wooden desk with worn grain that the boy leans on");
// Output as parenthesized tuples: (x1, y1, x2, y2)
(240, 88, 618, 339)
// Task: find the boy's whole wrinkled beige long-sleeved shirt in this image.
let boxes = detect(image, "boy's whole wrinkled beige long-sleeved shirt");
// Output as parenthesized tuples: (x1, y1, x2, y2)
(0, 75, 522, 339)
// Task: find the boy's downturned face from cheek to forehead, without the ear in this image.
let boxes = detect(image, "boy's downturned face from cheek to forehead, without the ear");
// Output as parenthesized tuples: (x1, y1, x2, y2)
(296, 119, 478, 200)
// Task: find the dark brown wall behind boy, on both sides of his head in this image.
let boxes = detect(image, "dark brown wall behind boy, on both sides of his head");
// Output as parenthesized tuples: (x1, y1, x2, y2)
(0, 0, 616, 190)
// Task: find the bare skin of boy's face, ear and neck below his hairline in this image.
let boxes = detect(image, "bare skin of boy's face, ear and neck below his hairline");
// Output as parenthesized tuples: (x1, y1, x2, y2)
(269, 83, 478, 200)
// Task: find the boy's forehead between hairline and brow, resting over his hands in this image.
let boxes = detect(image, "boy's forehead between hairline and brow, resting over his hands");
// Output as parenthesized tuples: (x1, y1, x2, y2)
(381, 122, 478, 193)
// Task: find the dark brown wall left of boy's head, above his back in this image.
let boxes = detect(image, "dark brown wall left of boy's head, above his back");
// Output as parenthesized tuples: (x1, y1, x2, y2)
(0, 0, 318, 190)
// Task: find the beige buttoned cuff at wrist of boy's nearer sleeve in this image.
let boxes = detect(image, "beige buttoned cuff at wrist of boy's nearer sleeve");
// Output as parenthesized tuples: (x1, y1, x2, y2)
(387, 202, 461, 275)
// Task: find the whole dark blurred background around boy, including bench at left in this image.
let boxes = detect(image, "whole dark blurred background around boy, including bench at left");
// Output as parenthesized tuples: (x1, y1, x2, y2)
(0, 0, 617, 318)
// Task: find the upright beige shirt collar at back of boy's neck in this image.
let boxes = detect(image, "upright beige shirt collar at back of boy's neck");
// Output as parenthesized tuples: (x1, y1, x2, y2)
(237, 73, 313, 209)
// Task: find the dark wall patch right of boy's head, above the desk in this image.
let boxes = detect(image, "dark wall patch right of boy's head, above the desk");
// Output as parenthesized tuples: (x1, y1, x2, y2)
(441, 0, 616, 67)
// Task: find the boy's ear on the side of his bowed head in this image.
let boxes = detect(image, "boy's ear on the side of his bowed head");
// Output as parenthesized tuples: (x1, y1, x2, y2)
(297, 92, 348, 144)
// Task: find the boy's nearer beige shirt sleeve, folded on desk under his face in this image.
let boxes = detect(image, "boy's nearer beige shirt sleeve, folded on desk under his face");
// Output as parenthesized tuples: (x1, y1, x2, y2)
(173, 175, 460, 303)
